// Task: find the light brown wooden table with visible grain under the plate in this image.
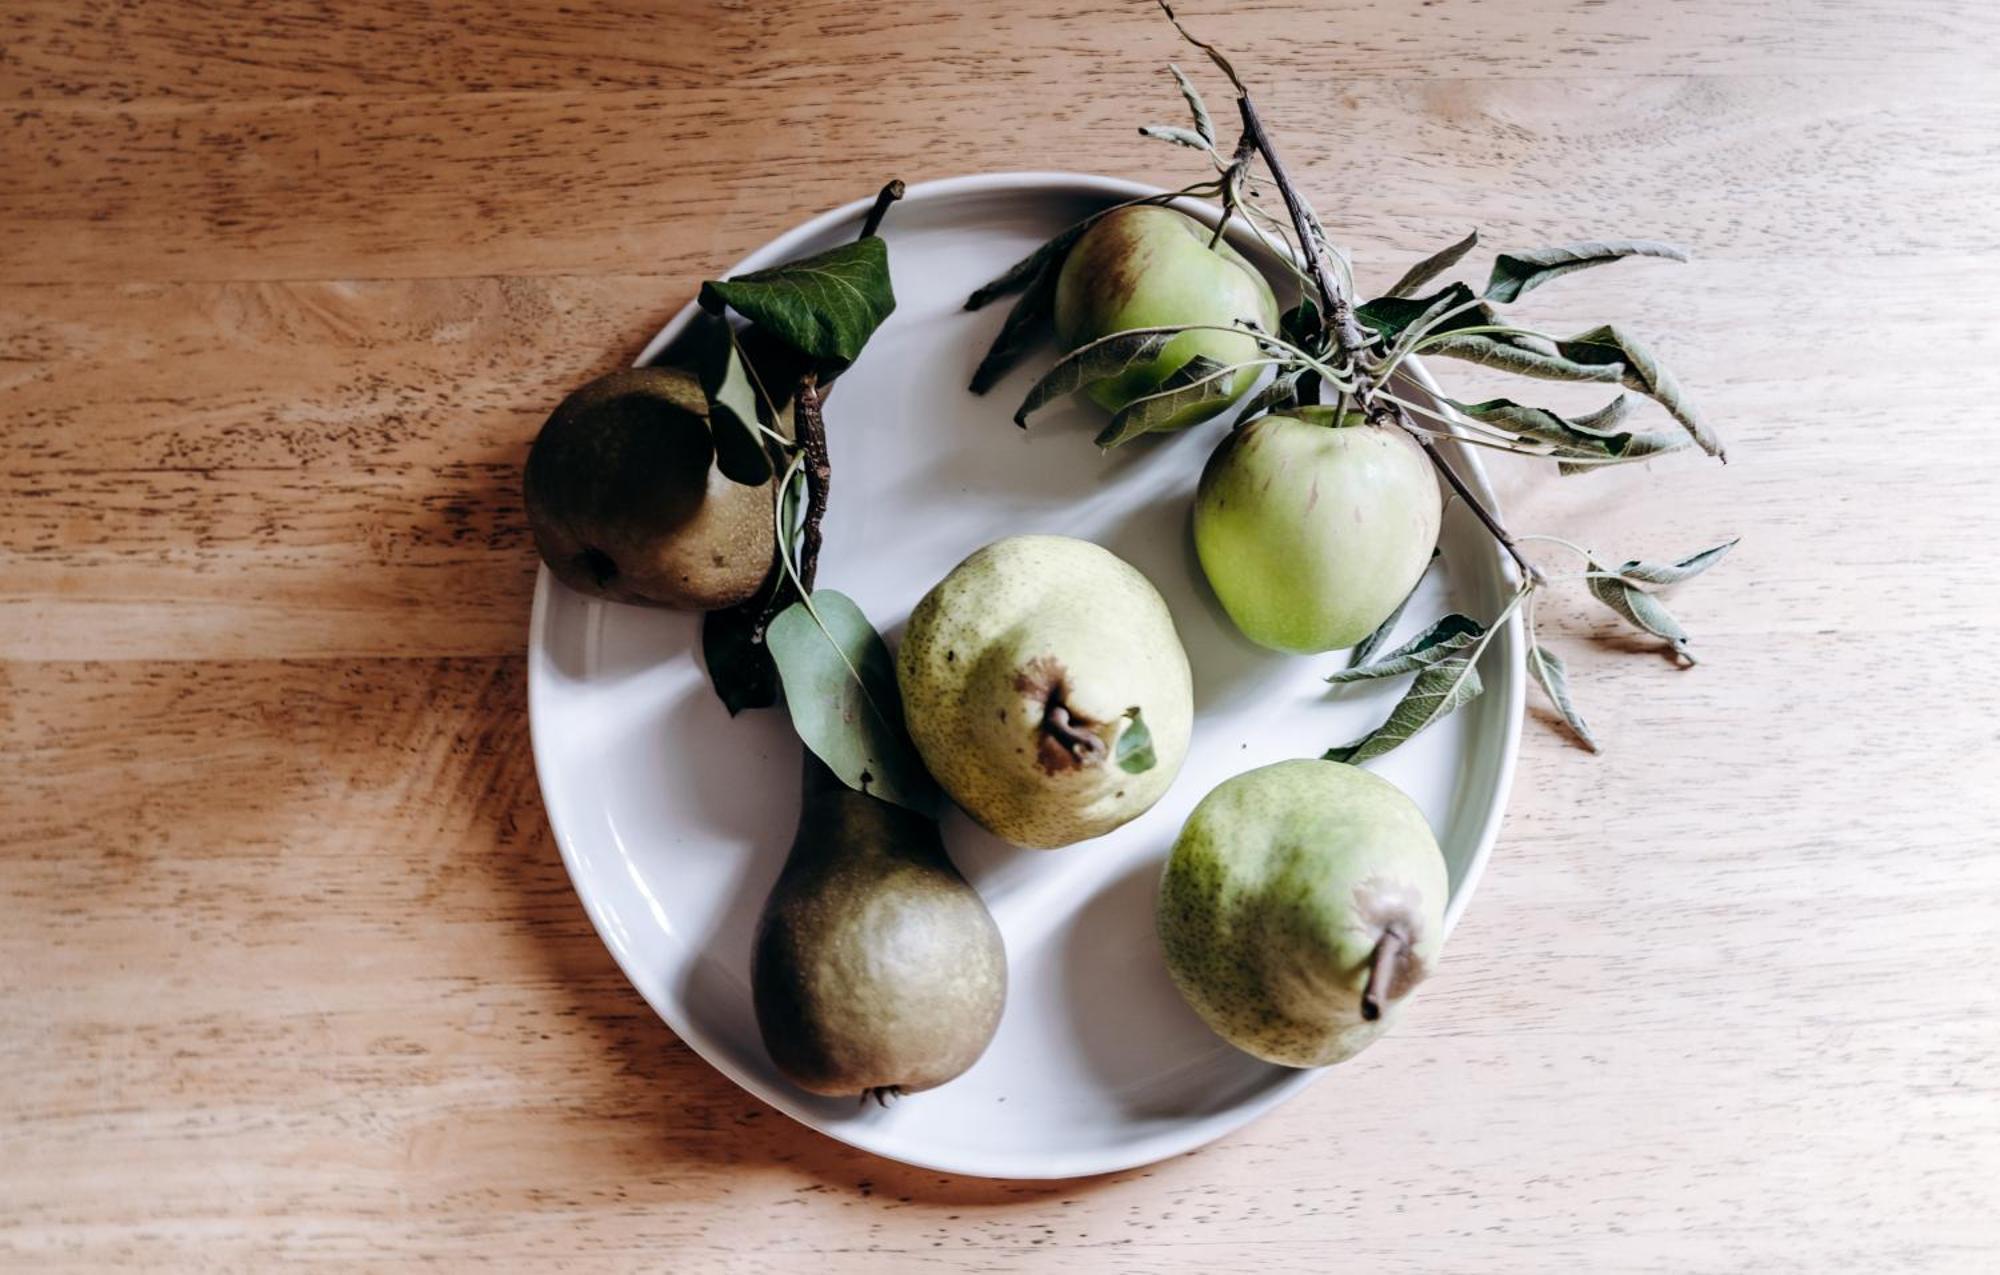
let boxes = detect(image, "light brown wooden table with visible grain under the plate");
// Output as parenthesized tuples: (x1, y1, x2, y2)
(0, 0, 2000, 1273)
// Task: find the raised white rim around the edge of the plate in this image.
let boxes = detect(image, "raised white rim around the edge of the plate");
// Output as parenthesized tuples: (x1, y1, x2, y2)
(526, 170, 1528, 1181)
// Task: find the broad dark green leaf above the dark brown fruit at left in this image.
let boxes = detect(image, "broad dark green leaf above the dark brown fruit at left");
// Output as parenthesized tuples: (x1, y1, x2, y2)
(700, 234, 896, 366)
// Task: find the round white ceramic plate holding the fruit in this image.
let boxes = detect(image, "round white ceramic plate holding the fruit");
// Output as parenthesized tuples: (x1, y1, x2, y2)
(528, 174, 1524, 1177)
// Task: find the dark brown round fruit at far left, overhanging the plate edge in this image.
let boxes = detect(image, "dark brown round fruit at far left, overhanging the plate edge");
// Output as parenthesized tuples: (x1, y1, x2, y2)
(524, 368, 776, 612)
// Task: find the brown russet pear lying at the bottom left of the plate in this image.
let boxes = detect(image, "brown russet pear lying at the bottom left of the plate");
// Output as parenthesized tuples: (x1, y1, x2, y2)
(750, 753, 1006, 1099)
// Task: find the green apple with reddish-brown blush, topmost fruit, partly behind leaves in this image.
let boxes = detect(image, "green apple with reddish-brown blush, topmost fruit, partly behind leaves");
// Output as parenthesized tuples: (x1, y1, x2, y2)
(1056, 206, 1278, 430)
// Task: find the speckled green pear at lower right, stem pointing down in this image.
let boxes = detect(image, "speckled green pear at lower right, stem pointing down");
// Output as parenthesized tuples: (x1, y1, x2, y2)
(1158, 759, 1448, 1067)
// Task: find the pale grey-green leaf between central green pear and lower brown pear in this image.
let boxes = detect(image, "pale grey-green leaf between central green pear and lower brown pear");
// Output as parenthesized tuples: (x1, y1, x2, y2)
(766, 590, 936, 815)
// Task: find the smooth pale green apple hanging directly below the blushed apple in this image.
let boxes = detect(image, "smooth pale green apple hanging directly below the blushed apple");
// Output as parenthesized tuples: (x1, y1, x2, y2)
(1194, 408, 1444, 653)
